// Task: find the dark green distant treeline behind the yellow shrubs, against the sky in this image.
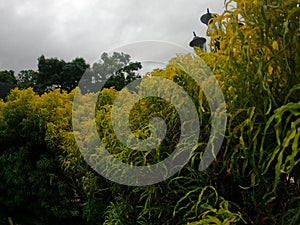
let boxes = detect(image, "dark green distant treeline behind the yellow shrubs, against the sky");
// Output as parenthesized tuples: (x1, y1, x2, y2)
(0, 52, 142, 98)
